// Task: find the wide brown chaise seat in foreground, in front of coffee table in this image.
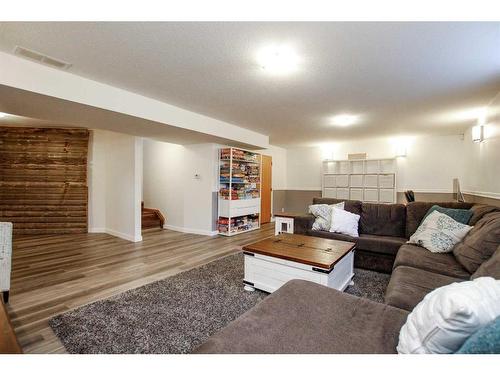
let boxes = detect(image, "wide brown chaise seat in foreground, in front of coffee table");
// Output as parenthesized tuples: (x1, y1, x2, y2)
(195, 280, 408, 353)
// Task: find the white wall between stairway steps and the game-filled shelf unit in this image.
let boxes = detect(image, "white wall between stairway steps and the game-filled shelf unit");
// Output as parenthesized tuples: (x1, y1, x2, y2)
(143, 139, 217, 235)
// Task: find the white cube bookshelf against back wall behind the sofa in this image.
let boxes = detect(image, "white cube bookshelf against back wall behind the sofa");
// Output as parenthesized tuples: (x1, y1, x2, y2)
(321, 158, 397, 203)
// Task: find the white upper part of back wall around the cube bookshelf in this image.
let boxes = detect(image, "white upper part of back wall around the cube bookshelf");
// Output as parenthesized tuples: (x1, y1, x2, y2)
(287, 135, 464, 193)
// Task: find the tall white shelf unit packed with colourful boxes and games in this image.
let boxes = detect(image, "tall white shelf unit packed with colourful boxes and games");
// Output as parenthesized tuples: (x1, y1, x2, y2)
(217, 147, 261, 236)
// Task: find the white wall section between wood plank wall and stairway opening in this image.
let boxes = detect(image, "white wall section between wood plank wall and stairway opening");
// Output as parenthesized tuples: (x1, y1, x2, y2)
(89, 130, 142, 242)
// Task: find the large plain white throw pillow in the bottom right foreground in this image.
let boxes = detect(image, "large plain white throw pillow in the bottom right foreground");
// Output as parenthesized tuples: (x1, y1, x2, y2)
(397, 277, 500, 354)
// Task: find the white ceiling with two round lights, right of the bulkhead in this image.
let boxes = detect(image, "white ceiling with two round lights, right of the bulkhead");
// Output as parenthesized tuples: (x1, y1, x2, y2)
(0, 22, 500, 146)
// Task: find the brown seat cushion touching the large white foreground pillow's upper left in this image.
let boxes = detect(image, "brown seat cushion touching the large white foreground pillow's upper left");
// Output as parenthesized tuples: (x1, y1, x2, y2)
(385, 266, 463, 311)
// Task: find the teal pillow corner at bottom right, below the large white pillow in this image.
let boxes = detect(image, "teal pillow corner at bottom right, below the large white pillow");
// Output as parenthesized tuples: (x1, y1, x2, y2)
(455, 316, 500, 354)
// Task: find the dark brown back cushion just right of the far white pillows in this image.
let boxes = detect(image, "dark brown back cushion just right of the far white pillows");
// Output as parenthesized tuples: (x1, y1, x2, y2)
(359, 203, 406, 237)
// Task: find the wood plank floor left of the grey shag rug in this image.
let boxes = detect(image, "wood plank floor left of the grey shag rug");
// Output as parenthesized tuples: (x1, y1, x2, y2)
(8, 223, 274, 353)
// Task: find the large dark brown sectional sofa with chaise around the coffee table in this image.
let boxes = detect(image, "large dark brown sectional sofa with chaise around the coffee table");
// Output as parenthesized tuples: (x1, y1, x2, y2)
(195, 198, 500, 353)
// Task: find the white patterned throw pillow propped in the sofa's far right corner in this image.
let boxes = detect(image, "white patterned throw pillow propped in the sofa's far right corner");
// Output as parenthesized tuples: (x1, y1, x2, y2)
(408, 211, 472, 253)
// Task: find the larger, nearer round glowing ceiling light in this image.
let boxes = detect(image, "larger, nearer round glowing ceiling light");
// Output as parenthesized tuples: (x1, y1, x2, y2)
(257, 45, 299, 75)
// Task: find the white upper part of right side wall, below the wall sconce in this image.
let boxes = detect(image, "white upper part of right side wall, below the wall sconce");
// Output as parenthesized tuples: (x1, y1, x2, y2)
(462, 93, 500, 199)
